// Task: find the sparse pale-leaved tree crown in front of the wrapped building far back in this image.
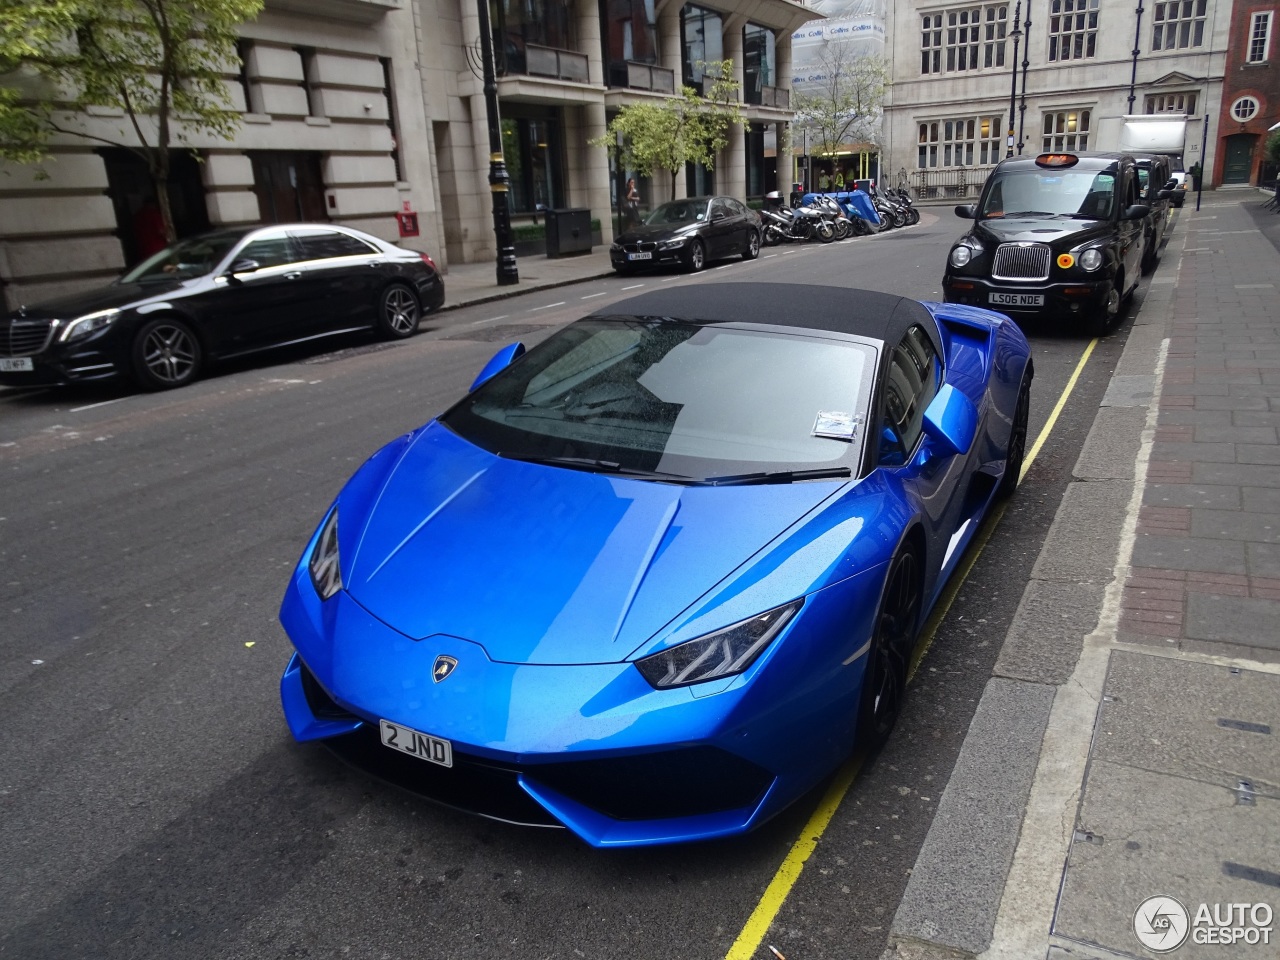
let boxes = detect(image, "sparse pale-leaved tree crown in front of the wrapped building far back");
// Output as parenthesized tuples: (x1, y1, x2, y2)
(791, 42, 888, 160)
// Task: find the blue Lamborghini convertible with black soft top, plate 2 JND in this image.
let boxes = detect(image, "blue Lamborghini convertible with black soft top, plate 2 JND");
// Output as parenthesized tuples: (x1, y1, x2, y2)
(280, 284, 1032, 846)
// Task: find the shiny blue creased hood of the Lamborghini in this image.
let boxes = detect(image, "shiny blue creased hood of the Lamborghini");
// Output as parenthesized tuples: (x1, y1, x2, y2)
(338, 424, 844, 664)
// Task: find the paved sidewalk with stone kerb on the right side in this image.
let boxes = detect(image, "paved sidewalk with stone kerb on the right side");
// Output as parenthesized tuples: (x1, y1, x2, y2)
(886, 193, 1280, 960)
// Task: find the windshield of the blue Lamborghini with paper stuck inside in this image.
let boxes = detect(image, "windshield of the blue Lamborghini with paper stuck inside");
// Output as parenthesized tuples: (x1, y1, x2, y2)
(440, 317, 876, 479)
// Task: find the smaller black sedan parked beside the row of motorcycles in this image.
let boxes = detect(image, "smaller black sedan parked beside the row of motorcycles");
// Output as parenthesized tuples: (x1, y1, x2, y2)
(609, 197, 760, 274)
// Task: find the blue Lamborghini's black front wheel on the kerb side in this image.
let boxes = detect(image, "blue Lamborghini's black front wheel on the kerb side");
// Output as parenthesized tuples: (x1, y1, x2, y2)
(858, 545, 924, 753)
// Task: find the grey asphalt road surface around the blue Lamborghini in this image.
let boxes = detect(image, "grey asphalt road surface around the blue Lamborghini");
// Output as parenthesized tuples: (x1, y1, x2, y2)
(0, 218, 1157, 960)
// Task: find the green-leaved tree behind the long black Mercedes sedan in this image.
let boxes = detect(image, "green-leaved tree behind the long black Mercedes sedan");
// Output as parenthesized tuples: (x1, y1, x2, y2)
(0, 0, 262, 241)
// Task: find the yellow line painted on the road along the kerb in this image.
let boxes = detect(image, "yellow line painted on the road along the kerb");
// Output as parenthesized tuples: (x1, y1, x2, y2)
(724, 339, 1098, 960)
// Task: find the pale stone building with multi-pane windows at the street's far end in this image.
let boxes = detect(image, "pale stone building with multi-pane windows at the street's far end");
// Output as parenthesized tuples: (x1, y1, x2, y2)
(884, 0, 1231, 197)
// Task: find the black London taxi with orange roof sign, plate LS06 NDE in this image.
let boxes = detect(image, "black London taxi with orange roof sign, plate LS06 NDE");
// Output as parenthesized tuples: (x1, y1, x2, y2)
(942, 154, 1151, 334)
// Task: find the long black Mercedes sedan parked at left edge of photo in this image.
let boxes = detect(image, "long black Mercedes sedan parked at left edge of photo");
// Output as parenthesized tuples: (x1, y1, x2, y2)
(0, 224, 444, 390)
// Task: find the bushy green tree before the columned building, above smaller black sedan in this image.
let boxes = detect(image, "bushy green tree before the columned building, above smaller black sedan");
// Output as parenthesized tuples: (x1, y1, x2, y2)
(589, 60, 746, 196)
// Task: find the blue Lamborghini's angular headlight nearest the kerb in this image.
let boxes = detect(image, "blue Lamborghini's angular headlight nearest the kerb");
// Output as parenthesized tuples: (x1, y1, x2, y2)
(636, 596, 804, 690)
